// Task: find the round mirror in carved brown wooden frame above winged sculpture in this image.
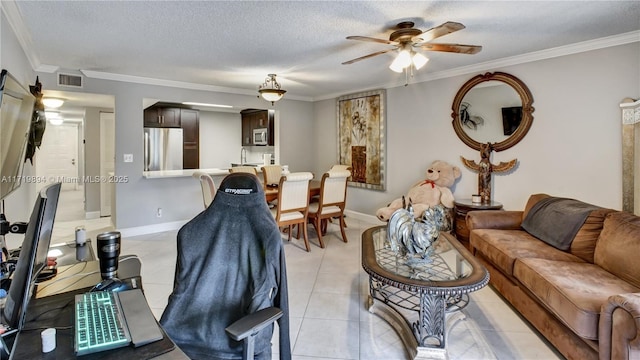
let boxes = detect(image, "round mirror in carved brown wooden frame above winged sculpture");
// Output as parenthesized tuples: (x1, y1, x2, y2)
(451, 72, 534, 151)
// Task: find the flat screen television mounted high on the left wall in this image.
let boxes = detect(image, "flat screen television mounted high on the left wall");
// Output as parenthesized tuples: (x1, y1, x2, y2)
(0, 69, 36, 199)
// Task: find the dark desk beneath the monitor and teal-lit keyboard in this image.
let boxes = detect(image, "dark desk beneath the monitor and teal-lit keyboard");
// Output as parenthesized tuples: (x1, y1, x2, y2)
(10, 255, 188, 360)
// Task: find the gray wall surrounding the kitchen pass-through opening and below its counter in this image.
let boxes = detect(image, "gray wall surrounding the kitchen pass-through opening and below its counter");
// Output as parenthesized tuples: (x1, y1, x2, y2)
(30, 73, 315, 229)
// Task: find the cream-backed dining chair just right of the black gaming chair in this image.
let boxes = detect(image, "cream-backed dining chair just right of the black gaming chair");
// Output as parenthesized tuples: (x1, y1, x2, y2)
(271, 172, 313, 251)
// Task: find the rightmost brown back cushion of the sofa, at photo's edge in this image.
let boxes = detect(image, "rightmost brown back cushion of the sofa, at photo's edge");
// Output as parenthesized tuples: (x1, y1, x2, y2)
(594, 211, 640, 287)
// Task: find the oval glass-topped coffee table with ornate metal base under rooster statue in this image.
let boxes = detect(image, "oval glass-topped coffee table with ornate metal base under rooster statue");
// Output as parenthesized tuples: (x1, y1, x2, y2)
(362, 225, 489, 359)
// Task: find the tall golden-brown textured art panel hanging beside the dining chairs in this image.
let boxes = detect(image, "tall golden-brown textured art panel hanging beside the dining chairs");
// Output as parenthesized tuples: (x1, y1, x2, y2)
(336, 90, 386, 190)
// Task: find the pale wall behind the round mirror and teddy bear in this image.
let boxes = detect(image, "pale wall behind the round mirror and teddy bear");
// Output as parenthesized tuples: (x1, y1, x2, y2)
(314, 42, 640, 214)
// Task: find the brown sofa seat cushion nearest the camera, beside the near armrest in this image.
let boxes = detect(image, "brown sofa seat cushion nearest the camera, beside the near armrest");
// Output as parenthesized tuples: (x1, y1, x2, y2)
(513, 258, 640, 340)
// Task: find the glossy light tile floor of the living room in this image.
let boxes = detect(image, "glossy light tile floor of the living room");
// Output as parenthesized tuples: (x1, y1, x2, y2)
(46, 188, 562, 360)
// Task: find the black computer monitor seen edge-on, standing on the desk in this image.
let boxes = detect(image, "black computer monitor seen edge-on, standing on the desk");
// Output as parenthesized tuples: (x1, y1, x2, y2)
(2, 183, 61, 330)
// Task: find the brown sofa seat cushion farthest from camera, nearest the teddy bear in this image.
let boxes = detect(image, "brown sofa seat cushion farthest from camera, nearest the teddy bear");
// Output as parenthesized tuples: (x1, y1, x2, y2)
(469, 229, 583, 276)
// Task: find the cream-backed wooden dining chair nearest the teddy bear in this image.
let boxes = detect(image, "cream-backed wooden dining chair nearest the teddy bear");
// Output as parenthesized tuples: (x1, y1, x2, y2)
(307, 169, 351, 248)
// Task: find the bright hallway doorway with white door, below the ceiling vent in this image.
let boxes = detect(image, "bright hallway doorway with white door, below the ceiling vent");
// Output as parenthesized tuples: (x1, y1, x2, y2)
(34, 90, 115, 223)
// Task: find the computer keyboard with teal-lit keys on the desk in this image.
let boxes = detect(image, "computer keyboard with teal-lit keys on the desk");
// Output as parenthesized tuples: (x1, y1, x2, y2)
(75, 291, 131, 355)
